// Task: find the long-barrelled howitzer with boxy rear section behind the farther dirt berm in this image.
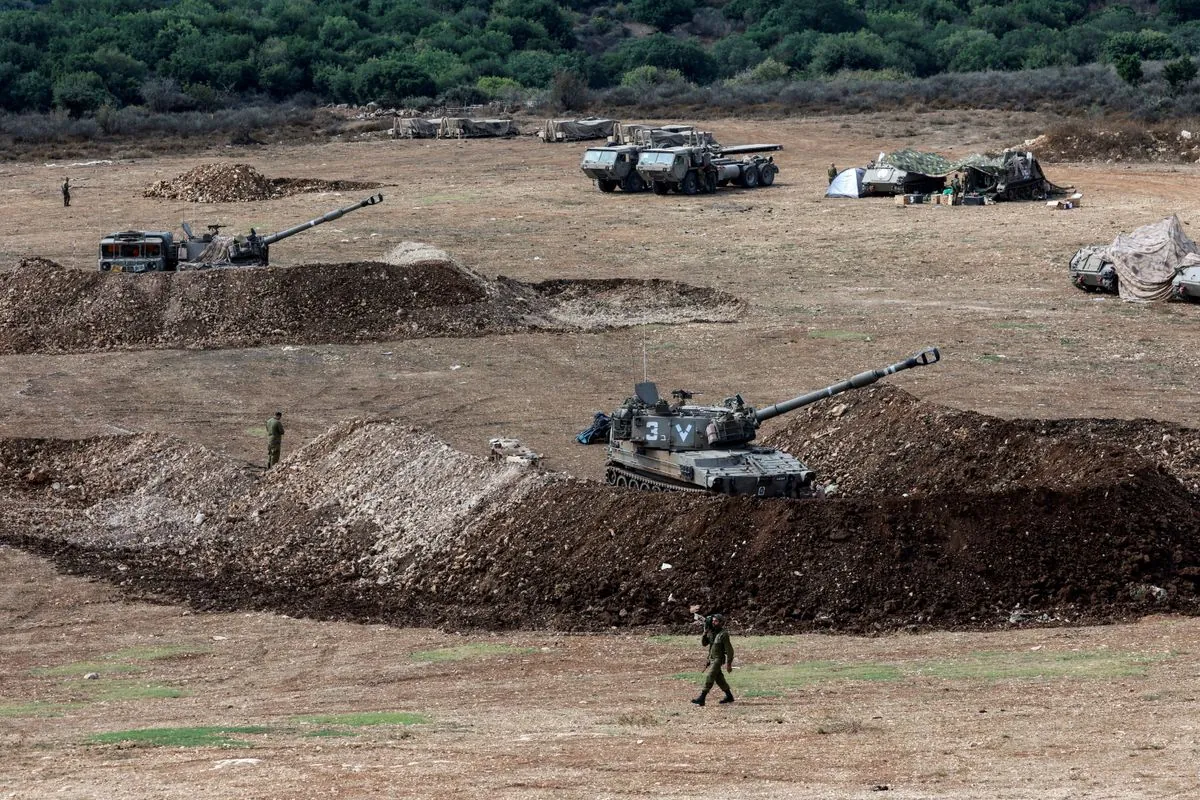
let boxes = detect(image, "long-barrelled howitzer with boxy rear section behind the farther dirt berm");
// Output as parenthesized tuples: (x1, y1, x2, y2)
(100, 194, 383, 272)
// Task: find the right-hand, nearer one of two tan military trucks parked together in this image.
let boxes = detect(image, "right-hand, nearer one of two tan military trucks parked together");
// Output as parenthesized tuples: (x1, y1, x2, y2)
(637, 144, 782, 194)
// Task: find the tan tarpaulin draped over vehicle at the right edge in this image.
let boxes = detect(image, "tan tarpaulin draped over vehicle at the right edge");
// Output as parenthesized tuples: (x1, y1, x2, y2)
(1108, 216, 1200, 300)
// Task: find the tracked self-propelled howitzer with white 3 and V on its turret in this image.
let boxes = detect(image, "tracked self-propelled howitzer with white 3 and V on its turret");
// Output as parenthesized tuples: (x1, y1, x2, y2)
(605, 348, 941, 498)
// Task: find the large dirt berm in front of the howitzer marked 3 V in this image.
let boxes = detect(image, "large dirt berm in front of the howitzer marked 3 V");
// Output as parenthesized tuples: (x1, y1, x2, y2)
(0, 389, 1200, 632)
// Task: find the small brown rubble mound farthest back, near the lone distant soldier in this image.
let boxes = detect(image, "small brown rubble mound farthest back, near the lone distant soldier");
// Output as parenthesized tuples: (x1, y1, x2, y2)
(142, 163, 380, 203)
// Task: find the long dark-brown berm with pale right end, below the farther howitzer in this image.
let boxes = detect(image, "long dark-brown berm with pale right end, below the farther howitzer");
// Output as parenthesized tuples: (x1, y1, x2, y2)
(0, 245, 745, 354)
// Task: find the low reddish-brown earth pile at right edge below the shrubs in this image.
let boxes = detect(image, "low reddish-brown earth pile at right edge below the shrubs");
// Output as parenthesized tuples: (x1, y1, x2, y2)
(1024, 122, 1200, 163)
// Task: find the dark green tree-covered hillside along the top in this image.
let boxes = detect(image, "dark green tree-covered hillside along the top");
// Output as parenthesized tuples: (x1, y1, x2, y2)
(0, 0, 1200, 114)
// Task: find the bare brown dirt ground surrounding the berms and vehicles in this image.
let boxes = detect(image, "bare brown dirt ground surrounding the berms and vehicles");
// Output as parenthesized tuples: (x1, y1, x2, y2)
(0, 113, 1200, 798)
